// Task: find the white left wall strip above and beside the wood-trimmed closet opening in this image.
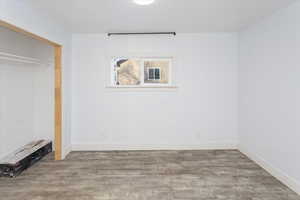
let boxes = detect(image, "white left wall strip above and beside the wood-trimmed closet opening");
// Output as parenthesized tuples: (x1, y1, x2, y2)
(0, 0, 72, 157)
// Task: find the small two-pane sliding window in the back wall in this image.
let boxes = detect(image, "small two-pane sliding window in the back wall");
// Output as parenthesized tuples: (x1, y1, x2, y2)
(111, 58, 172, 87)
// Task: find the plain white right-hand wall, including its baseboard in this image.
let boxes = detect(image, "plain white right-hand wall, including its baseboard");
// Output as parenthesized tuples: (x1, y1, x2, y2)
(239, 1, 300, 193)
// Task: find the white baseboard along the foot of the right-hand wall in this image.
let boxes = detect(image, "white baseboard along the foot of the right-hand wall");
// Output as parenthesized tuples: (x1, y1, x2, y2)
(238, 146, 300, 195)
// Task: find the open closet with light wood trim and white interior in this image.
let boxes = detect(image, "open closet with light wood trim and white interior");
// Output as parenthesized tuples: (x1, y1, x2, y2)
(0, 20, 62, 160)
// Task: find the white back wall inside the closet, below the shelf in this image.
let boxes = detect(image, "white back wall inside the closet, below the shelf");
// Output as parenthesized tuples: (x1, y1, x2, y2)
(0, 61, 35, 159)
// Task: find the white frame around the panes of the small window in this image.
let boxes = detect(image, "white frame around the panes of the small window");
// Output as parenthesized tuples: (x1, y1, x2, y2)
(109, 56, 175, 88)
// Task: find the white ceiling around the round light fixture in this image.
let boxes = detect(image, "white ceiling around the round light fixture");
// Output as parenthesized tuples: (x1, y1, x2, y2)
(30, 0, 298, 33)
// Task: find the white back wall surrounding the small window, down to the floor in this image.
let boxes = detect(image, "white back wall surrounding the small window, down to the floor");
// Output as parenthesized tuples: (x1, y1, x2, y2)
(72, 33, 238, 150)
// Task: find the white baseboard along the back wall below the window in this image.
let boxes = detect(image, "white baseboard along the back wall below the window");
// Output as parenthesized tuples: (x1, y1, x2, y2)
(72, 142, 237, 151)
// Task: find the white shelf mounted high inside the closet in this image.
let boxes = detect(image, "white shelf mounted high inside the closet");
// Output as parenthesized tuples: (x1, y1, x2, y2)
(0, 51, 53, 66)
